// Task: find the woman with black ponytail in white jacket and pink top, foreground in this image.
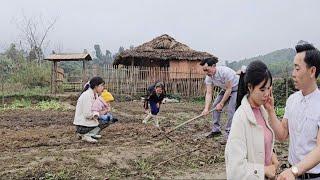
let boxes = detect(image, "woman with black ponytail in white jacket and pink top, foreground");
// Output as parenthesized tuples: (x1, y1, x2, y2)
(225, 61, 278, 180)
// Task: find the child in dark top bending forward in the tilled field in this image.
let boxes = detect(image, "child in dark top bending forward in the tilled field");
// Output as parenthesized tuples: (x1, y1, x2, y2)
(142, 82, 165, 127)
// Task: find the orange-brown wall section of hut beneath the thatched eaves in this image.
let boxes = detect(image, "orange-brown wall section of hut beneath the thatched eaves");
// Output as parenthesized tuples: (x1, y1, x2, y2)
(169, 60, 205, 79)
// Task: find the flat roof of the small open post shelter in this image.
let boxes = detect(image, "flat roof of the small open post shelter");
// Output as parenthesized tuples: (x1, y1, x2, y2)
(44, 53, 92, 61)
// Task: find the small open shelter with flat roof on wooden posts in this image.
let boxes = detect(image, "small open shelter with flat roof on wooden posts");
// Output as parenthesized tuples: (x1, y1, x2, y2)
(44, 52, 92, 93)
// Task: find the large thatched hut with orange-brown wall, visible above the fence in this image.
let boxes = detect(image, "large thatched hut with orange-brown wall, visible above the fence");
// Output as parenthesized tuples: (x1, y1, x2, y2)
(114, 34, 218, 78)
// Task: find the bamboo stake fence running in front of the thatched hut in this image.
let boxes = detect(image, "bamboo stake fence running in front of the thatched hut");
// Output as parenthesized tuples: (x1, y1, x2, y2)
(63, 65, 217, 97)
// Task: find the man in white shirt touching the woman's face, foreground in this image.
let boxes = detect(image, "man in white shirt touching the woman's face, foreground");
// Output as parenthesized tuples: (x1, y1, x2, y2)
(266, 42, 320, 180)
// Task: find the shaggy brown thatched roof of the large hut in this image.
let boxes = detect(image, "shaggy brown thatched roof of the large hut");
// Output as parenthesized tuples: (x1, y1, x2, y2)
(114, 34, 216, 65)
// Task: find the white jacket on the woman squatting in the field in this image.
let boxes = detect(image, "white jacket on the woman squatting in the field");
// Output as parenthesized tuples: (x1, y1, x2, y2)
(73, 88, 99, 127)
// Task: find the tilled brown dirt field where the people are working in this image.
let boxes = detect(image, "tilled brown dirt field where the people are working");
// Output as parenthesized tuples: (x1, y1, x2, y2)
(0, 102, 287, 179)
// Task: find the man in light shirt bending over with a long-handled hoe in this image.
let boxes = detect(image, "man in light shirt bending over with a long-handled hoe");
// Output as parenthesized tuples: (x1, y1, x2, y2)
(200, 58, 239, 138)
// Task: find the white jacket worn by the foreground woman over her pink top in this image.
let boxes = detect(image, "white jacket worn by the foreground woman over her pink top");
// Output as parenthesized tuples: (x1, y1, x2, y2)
(225, 95, 274, 180)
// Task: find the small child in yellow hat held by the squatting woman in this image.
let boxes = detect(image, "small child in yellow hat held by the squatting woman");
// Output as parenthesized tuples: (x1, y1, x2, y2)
(91, 90, 118, 124)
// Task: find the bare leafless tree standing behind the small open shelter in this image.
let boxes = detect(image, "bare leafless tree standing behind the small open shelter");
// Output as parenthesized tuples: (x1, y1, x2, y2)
(17, 15, 57, 64)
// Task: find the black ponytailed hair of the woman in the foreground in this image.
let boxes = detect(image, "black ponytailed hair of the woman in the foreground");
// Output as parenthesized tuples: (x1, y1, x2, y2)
(236, 60, 272, 109)
